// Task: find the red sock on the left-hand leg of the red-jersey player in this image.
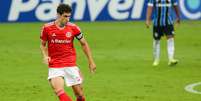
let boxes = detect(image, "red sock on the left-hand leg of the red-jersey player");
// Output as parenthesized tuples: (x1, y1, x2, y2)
(57, 90, 72, 101)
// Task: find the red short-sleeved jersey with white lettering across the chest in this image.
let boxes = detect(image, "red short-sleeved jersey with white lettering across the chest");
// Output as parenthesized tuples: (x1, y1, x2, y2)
(40, 22, 82, 68)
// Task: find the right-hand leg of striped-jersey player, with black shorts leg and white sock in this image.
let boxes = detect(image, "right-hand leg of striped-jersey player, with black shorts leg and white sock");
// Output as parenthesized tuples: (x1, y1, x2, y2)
(165, 25, 178, 65)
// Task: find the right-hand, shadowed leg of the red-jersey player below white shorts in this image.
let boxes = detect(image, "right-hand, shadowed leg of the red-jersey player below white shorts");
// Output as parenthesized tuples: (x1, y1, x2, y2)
(72, 84, 85, 101)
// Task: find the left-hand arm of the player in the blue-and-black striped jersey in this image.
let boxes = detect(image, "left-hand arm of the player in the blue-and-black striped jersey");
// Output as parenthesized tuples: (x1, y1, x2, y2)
(146, 0, 153, 28)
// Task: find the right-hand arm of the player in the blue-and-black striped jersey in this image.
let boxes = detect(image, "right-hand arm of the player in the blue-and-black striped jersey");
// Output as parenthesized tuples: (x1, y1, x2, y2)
(173, 0, 180, 24)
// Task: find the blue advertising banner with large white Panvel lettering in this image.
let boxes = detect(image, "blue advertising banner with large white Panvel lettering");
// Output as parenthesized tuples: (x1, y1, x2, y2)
(0, 0, 201, 22)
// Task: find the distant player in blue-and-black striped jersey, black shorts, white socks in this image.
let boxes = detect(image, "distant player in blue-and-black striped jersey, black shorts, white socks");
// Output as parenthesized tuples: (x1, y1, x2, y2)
(146, 0, 180, 66)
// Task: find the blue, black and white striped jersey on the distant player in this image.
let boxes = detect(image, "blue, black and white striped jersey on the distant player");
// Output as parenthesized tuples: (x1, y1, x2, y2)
(148, 0, 178, 26)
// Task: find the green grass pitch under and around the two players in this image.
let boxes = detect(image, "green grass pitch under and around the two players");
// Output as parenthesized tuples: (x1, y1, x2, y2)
(0, 21, 201, 101)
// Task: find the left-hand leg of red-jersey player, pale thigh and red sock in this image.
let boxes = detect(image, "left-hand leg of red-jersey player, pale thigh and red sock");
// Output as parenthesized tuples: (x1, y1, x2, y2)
(49, 77, 72, 101)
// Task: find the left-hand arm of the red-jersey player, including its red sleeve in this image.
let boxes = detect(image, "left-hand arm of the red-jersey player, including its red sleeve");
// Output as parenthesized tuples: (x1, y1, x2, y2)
(40, 27, 50, 64)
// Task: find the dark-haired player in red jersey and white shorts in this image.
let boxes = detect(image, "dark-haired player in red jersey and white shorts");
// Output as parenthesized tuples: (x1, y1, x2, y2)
(40, 4, 96, 101)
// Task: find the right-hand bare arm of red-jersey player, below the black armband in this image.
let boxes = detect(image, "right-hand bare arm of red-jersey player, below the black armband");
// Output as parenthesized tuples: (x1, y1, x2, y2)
(77, 36, 96, 73)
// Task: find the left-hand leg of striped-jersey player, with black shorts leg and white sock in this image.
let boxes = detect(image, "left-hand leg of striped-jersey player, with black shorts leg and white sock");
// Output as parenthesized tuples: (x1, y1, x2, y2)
(153, 26, 162, 66)
